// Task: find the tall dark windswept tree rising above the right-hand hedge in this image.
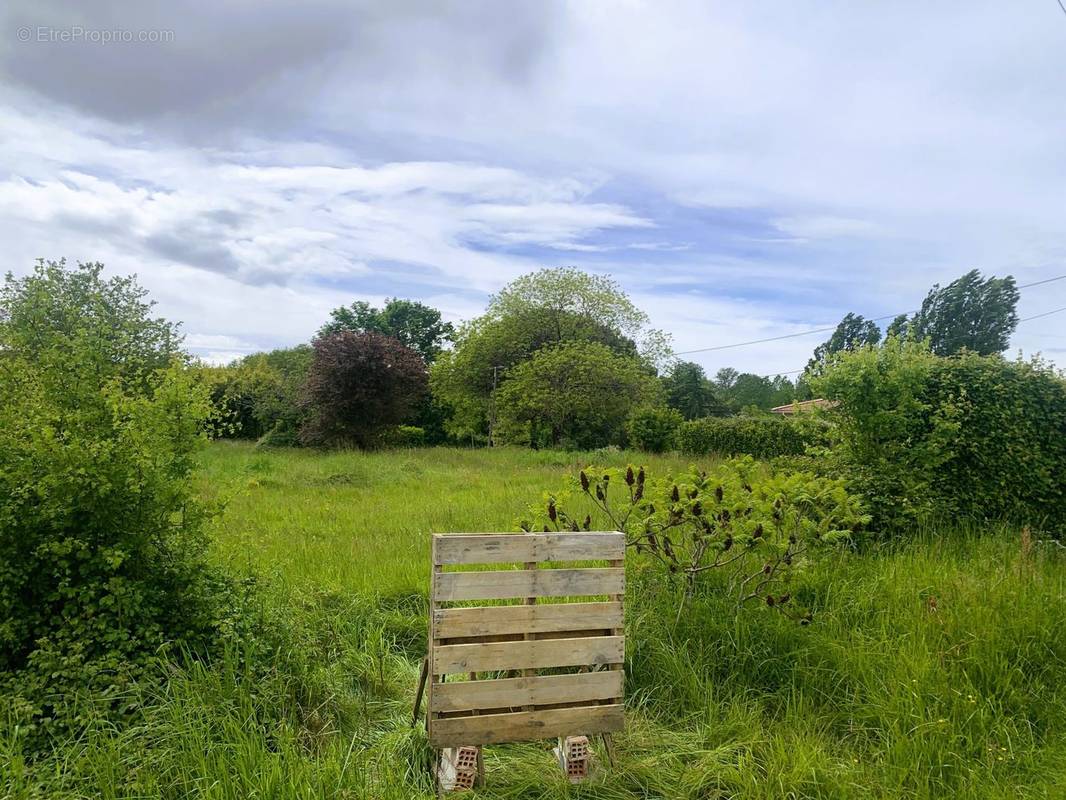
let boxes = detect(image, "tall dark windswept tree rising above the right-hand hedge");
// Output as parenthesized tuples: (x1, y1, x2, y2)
(907, 270, 1018, 355)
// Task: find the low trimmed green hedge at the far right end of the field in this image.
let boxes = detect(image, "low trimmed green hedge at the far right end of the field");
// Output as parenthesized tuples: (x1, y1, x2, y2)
(677, 416, 817, 459)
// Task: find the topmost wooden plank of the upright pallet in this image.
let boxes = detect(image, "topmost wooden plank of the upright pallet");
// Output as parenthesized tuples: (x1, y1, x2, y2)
(434, 531, 626, 564)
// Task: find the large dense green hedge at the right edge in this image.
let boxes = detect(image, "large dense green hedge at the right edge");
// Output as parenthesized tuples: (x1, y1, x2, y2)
(818, 339, 1066, 530)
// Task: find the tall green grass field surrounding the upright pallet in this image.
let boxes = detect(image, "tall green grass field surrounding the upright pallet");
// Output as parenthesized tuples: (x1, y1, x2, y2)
(0, 444, 1066, 800)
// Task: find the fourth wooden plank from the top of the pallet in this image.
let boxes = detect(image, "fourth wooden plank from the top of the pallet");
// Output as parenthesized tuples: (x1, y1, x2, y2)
(432, 636, 626, 675)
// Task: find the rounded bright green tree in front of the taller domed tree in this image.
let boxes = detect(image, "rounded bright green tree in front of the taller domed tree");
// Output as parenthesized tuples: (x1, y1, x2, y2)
(497, 341, 661, 448)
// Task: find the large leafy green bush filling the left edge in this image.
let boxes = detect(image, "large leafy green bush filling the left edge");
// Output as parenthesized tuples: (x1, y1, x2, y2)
(0, 262, 220, 741)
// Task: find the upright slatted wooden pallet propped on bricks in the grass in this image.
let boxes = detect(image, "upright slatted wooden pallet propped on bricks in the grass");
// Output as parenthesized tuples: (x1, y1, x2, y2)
(416, 532, 626, 789)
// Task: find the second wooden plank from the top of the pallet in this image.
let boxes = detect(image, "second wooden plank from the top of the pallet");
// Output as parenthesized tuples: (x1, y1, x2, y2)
(432, 567, 626, 603)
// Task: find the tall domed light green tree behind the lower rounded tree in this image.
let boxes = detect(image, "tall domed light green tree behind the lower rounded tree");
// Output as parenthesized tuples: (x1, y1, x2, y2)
(431, 269, 668, 437)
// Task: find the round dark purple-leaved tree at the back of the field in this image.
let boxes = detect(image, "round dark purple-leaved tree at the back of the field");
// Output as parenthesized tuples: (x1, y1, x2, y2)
(300, 331, 426, 447)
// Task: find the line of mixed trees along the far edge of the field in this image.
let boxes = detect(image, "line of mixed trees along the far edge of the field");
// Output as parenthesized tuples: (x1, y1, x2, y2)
(203, 268, 1018, 448)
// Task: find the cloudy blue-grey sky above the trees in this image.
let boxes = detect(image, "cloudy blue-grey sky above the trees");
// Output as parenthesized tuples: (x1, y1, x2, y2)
(0, 0, 1066, 374)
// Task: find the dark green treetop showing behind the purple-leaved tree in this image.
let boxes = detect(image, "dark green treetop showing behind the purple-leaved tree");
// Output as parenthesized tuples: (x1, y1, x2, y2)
(319, 298, 455, 364)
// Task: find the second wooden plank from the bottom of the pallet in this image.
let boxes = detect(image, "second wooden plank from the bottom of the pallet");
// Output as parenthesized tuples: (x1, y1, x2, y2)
(433, 672, 621, 711)
